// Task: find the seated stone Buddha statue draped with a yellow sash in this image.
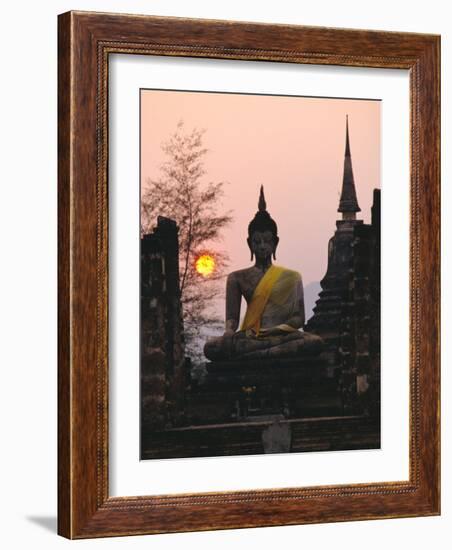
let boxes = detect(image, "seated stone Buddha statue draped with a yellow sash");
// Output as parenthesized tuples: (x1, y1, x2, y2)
(204, 186, 323, 361)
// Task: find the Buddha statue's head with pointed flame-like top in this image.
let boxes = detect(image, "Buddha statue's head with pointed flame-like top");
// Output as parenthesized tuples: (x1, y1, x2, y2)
(247, 185, 279, 261)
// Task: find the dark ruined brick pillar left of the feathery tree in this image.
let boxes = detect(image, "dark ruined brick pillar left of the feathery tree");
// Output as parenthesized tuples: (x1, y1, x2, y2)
(140, 216, 188, 440)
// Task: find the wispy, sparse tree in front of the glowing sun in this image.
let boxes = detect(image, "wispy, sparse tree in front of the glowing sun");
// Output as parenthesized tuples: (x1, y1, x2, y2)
(141, 121, 232, 361)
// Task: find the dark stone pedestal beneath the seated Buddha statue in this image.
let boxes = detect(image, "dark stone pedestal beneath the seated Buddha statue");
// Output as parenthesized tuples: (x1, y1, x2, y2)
(186, 355, 343, 424)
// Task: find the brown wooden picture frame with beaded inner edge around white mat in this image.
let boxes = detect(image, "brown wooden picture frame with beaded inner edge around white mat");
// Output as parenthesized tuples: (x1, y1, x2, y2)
(58, 12, 440, 538)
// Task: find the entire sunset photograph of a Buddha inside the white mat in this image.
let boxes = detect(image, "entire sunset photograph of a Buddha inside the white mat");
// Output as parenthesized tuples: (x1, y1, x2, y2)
(137, 88, 384, 460)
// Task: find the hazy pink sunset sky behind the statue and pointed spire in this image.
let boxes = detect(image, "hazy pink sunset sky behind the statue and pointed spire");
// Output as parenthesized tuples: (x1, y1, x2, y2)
(141, 90, 381, 294)
